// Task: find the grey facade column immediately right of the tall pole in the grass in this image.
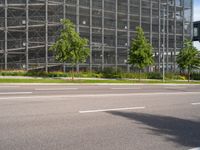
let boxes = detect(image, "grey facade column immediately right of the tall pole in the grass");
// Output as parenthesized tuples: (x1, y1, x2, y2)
(165, 0, 169, 72)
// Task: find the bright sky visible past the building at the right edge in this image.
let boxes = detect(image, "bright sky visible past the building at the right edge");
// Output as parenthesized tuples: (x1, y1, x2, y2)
(194, 0, 200, 50)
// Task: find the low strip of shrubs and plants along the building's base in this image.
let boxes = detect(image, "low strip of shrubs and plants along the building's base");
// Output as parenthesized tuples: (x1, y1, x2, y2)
(0, 68, 200, 80)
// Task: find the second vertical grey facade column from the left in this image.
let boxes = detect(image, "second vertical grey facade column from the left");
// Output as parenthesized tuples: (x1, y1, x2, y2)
(26, 0, 29, 71)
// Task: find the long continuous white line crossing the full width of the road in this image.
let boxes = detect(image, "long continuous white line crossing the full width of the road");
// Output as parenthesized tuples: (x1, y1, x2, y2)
(0, 92, 200, 100)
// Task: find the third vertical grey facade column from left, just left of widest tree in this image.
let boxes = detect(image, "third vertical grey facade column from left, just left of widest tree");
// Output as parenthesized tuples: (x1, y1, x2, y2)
(45, 0, 48, 72)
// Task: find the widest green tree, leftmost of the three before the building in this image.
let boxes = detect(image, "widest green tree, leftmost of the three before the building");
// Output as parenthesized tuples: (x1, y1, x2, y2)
(50, 19, 90, 80)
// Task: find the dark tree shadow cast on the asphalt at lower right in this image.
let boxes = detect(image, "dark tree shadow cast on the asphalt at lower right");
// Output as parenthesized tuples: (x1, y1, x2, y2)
(109, 111, 200, 147)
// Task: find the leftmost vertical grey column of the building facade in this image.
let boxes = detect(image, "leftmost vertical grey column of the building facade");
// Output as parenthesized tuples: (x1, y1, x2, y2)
(4, 0, 8, 70)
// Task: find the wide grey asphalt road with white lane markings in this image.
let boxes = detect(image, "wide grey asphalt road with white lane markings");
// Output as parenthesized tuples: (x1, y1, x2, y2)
(0, 84, 200, 150)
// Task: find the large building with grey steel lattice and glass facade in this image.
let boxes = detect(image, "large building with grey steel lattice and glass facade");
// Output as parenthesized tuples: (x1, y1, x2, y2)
(0, 0, 193, 71)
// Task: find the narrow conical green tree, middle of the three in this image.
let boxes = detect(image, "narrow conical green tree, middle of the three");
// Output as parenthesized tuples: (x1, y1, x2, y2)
(128, 27, 154, 79)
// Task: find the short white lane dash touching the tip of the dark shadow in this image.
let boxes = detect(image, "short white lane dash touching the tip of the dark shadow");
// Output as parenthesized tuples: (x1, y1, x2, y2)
(79, 106, 146, 114)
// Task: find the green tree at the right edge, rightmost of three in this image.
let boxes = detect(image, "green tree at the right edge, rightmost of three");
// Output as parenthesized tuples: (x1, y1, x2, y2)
(177, 40, 200, 82)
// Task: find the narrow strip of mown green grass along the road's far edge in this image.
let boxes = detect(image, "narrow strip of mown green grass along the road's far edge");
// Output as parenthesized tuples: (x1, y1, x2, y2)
(0, 78, 200, 84)
